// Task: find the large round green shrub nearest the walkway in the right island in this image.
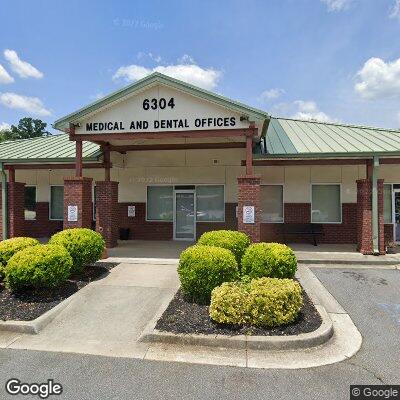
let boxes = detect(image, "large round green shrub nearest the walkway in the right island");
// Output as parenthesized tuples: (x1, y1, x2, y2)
(178, 245, 239, 304)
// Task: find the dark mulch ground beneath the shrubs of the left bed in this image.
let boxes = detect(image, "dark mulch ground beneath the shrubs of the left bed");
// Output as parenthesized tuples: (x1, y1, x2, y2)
(0, 262, 118, 321)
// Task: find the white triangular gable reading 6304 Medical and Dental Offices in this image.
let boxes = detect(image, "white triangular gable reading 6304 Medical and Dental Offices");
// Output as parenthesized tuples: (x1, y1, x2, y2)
(76, 85, 249, 134)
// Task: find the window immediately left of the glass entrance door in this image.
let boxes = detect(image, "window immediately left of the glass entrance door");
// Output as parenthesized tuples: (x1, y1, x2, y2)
(147, 186, 173, 221)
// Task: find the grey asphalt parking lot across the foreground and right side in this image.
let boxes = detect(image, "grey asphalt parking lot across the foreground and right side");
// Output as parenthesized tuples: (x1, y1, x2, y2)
(0, 268, 400, 400)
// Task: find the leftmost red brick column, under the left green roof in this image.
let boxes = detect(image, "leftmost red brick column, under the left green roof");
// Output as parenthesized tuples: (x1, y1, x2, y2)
(8, 182, 25, 238)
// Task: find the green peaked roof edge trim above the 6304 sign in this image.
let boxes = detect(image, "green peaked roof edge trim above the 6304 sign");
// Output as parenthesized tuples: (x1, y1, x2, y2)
(53, 72, 268, 130)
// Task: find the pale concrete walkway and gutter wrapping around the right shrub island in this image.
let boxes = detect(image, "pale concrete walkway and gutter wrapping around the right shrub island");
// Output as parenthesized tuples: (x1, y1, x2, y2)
(0, 259, 361, 368)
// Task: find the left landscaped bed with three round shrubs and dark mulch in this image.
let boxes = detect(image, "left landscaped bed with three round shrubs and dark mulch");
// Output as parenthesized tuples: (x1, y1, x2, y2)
(0, 228, 114, 321)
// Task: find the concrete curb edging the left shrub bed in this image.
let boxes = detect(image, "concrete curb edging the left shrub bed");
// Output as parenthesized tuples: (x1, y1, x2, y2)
(0, 285, 83, 335)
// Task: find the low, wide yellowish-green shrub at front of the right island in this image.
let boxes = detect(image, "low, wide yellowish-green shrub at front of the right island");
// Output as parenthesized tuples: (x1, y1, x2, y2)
(209, 278, 303, 327)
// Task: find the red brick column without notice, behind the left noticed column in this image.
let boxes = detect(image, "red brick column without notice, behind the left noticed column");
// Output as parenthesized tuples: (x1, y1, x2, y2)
(96, 181, 119, 248)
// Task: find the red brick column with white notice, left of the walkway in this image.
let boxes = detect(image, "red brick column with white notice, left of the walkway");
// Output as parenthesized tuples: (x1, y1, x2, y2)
(64, 177, 93, 229)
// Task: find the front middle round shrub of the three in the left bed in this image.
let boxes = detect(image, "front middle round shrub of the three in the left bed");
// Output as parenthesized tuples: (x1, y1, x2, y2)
(5, 244, 72, 291)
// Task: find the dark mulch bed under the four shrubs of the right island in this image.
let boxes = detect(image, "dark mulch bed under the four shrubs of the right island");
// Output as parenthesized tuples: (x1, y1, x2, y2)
(156, 289, 322, 336)
